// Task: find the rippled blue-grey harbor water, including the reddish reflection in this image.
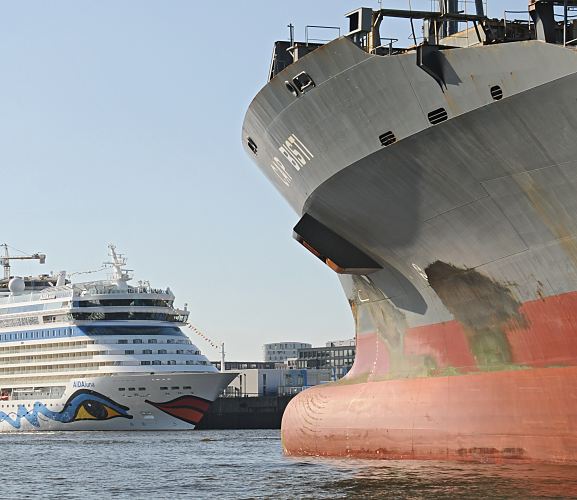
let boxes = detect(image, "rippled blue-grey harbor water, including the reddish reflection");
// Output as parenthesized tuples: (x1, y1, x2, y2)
(0, 431, 577, 500)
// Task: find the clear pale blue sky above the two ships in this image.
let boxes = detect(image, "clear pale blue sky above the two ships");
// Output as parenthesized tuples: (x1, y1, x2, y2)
(0, 0, 526, 360)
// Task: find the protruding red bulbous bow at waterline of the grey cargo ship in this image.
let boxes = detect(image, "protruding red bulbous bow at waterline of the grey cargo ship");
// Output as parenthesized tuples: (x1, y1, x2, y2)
(282, 367, 577, 463)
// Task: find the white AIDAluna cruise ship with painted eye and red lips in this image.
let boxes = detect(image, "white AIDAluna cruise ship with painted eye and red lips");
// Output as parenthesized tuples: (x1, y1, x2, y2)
(0, 245, 236, 432)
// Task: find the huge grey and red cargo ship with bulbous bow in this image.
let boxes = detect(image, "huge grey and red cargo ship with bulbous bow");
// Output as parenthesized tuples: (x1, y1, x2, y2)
(242, 0, 577, 464)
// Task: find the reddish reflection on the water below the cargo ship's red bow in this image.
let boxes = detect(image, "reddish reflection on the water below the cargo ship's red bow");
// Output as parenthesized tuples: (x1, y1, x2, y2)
(292, 458, 577, 499)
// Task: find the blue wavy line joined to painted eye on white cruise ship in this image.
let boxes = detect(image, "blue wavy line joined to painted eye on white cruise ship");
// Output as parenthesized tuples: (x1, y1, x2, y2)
(0, 389, 132, 429)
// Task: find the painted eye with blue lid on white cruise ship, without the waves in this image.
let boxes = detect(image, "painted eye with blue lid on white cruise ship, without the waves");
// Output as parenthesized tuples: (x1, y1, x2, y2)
(59, 389, 132, 422)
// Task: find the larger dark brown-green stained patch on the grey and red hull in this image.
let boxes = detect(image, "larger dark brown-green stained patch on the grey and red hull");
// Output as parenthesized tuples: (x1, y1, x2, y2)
(425, 261, 527, 368)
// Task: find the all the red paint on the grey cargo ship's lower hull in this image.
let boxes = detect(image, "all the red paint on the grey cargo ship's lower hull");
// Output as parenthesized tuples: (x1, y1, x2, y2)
(282, 293, 577, 464)
